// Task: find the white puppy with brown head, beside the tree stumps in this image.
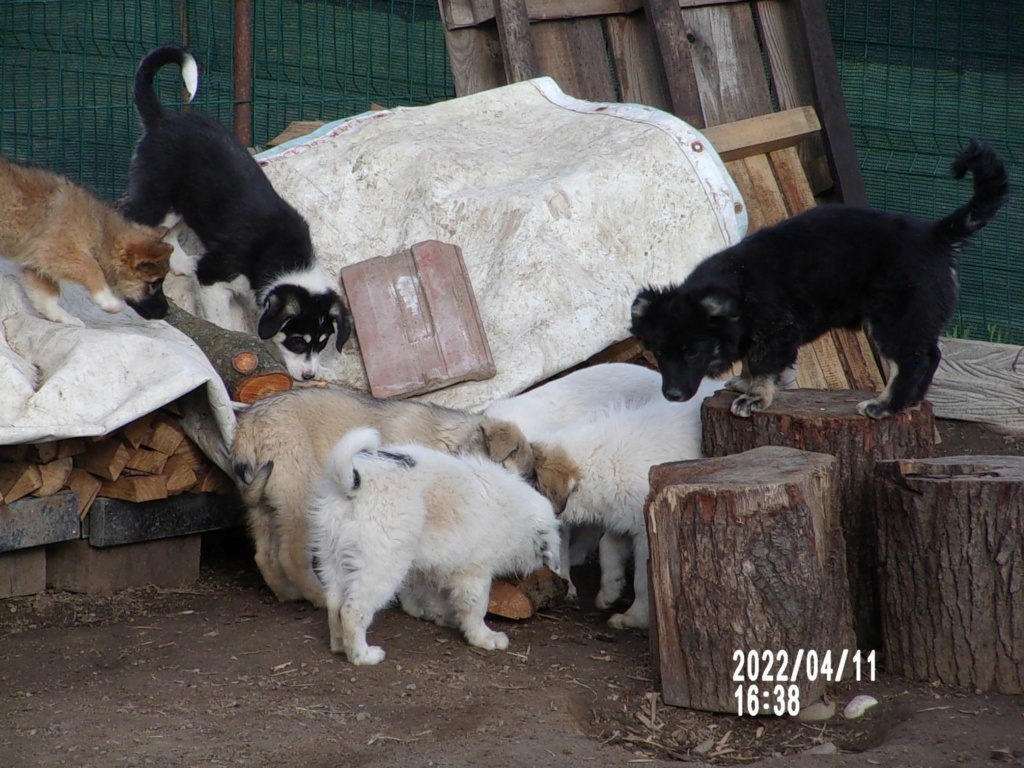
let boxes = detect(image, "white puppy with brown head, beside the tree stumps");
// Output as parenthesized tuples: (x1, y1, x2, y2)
(534, 379, 723, 629)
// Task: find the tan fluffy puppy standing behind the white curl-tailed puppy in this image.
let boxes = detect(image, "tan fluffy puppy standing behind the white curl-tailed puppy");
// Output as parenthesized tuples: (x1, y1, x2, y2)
(231, 387, 532, 606)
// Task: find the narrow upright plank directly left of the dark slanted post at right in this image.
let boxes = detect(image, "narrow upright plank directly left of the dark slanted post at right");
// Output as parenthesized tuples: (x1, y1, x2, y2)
(754, 0, 833, 195)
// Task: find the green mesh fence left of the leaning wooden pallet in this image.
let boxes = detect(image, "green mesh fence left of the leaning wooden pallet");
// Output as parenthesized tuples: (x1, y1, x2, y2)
(0, 0, 455, 200)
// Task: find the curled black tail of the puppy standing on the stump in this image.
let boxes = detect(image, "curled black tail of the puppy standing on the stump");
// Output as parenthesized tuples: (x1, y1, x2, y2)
(935, 139, 1010, 245)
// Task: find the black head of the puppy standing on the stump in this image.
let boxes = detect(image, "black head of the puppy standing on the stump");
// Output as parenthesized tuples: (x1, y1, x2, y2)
(630, 286, 740, 400)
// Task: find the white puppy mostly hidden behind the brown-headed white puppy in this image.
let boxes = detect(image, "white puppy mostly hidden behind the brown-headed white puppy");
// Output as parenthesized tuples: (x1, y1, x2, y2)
(483, 362, 664, 600)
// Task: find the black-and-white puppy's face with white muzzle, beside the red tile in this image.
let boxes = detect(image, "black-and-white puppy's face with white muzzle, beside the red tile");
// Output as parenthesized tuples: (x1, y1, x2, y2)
(257, 282, 352, 381)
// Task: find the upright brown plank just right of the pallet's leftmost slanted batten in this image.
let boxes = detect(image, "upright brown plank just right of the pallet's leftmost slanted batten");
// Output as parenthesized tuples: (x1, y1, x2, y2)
(532, 18, 616, 101)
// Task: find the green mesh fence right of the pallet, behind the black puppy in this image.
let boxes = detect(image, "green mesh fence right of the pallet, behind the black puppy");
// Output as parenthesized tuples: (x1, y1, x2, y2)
(825, 0, 1024, 344)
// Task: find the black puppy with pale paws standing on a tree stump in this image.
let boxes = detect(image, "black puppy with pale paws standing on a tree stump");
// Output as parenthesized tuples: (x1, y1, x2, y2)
(631, 140, 1008, 419)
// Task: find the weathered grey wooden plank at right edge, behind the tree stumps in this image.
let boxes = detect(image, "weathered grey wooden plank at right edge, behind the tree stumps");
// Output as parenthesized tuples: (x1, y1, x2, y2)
(928, 338, 1024, 432)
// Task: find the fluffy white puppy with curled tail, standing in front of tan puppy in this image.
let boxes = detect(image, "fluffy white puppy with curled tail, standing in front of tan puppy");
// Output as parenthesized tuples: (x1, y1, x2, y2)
(309, 428, 559, 665)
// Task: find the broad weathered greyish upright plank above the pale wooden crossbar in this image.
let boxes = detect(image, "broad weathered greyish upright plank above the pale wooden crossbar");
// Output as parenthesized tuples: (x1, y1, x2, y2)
(682, 5, 773, 125)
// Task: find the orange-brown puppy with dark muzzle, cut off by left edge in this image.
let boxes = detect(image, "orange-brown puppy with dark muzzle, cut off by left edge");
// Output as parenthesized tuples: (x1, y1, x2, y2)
(0, 158, 172, 326)
